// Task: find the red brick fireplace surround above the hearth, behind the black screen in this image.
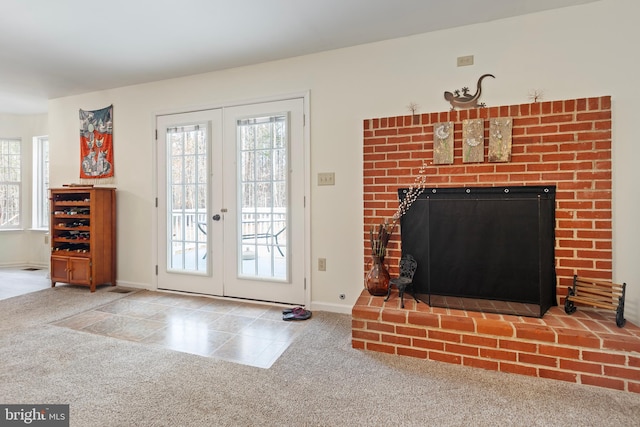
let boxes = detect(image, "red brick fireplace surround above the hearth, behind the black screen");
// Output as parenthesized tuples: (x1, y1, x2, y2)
(363, 96, 612, 303)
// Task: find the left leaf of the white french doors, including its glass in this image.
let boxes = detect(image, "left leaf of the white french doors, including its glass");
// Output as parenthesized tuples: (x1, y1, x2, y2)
(156, 109, 224, 295)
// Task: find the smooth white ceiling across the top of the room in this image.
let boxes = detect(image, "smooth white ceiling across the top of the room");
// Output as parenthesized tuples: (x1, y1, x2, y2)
(0, 0, 595, 114)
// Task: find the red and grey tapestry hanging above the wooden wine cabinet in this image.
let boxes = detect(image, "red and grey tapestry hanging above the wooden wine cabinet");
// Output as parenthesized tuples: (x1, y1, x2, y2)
(80, 105, 114, 184)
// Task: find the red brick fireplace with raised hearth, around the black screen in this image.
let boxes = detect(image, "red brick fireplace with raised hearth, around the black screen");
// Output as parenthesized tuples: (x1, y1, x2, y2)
(352, 96, 640, 393)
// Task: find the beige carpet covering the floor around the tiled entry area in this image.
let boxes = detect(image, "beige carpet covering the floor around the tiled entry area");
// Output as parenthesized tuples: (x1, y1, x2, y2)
(0, 286, 640, 427)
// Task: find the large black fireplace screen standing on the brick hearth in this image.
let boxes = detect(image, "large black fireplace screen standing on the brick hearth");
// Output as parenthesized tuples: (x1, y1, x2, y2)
(398, 186, 556, 317)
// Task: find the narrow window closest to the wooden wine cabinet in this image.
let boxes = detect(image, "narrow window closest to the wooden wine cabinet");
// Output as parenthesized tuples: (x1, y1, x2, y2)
(32, 136, 49, 229)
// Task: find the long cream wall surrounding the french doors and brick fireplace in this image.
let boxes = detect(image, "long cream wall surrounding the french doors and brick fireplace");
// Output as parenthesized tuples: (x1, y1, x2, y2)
(49, 0, 640, 322)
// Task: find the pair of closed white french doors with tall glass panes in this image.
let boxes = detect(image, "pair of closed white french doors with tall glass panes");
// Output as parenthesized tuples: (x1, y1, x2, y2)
(157, 98, 305, 304)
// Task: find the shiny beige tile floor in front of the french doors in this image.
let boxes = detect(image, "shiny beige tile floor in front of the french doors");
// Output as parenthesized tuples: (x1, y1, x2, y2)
(0, 269, 306, 369)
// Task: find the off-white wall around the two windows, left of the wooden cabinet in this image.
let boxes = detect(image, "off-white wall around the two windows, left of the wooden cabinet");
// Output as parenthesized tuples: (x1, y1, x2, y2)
(0, 114, 49, 267)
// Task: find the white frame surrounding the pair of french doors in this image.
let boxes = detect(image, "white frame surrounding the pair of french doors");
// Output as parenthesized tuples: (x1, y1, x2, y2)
(149, 91, 312, 307)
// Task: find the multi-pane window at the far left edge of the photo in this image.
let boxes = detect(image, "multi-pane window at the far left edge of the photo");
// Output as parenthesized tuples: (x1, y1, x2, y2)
(0, 138, 22, 230)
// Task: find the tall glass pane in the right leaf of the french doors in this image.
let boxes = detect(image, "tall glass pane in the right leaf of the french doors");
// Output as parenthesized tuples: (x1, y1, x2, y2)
(236, 114, 289, 281)
